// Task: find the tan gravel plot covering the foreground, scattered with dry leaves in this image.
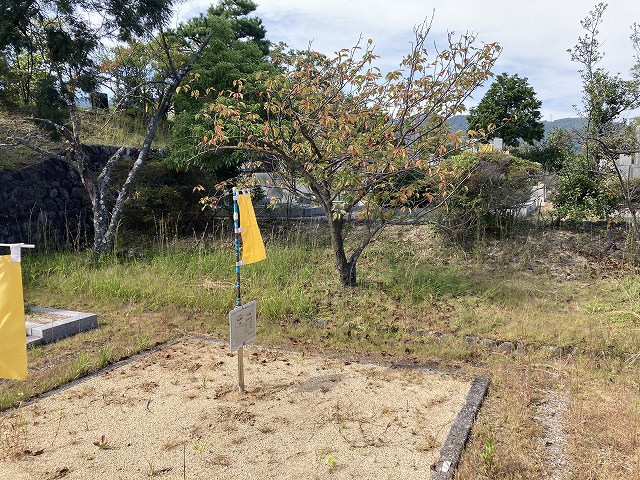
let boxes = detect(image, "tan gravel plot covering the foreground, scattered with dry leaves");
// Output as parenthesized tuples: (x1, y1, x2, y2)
(0, 340, 471, 480)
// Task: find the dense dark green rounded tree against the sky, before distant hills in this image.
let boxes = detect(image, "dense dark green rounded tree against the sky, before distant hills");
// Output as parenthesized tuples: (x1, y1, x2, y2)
(468, 73, 544, 146)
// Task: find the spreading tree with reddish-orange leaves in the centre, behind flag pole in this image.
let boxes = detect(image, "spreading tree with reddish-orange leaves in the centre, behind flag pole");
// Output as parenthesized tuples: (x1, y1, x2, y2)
(196, 23, 499, 286)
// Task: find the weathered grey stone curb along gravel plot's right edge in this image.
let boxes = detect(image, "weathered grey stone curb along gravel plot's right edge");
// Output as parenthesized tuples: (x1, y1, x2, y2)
(431, 375, 491, 480)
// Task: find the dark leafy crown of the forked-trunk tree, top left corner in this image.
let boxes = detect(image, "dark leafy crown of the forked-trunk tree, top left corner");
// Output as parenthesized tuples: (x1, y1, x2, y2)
(0, 0, 172, 113)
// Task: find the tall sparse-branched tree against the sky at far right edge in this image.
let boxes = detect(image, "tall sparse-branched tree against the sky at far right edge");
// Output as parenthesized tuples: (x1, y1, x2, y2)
(558, 3, 640, 231)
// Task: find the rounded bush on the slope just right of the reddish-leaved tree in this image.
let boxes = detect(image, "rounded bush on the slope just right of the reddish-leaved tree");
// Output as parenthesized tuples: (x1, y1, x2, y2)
(436, 151, 540, 245)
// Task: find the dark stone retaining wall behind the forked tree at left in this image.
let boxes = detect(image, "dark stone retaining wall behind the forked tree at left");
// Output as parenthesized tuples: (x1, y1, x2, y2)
(0, 146, 131, 249)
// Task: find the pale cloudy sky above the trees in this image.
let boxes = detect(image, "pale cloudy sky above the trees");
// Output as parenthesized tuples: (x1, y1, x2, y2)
(178, 0, 640, 121)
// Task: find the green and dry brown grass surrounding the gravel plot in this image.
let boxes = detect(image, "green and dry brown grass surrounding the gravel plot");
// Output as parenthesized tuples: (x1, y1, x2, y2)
(0, 223, 640, 479)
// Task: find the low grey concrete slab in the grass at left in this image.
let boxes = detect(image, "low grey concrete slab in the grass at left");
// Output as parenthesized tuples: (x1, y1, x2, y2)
(25, 307, 98, 347)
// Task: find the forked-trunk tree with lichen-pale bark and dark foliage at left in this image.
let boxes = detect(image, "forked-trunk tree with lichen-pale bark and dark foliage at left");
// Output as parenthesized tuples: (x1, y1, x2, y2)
(0, 0, 218, 257)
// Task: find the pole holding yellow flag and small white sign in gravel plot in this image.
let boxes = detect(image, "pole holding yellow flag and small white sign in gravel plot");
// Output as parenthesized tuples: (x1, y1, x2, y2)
(229, 188, 267, 393)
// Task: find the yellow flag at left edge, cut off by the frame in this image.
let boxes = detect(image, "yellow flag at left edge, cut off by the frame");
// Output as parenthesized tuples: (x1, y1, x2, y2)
(0, 255, 27, 380)
